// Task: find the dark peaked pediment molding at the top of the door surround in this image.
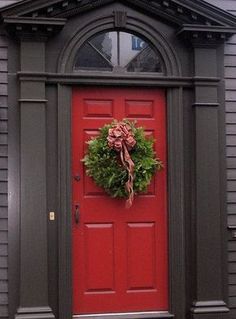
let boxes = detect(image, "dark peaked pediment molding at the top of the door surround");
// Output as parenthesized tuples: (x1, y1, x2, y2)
(0, 0, 236, 34)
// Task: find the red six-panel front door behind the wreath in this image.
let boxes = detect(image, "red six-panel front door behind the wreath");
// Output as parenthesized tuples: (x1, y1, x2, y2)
(72, 88, 168, 314)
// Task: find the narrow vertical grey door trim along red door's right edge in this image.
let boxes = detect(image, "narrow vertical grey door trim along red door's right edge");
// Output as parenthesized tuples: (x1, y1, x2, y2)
(167, 88, 186, 319)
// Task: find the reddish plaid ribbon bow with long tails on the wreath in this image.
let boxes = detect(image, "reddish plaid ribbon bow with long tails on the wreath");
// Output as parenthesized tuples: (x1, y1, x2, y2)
(107, 122, 136, 208)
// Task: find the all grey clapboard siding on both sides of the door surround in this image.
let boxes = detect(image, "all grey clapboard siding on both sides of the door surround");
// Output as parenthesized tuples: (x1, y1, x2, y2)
(0, 0, 236, 319)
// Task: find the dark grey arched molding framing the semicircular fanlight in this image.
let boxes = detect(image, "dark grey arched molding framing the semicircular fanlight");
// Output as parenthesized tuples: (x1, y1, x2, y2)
(57, 14, 182, 80)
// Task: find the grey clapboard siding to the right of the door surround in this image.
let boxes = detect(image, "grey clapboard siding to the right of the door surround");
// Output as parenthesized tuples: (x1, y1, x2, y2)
(208, 0, 236, 319)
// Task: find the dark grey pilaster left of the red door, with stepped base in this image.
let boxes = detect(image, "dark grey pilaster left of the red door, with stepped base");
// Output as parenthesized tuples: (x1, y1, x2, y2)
(15, 38, 55, 319)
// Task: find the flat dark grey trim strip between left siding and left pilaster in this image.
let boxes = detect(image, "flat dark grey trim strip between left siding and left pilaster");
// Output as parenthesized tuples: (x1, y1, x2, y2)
(8, 33, 20, 318)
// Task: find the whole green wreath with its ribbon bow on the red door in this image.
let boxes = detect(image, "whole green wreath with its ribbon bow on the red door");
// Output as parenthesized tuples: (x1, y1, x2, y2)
(82, 119, 163, 207)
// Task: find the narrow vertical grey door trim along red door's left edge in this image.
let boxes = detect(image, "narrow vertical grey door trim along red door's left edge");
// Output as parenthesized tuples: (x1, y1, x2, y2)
(58, 85, 72, 319)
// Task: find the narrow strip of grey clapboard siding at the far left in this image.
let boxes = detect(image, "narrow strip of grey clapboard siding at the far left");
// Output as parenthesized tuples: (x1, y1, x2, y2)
(0, 26, 8, 319)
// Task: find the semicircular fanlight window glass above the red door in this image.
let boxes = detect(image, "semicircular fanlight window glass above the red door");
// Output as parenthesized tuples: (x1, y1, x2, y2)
(74, 31, 163, 72)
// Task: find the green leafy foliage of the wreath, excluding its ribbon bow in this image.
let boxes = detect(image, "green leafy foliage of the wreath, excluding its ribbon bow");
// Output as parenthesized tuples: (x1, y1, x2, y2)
(82, 120, 163, 198)
